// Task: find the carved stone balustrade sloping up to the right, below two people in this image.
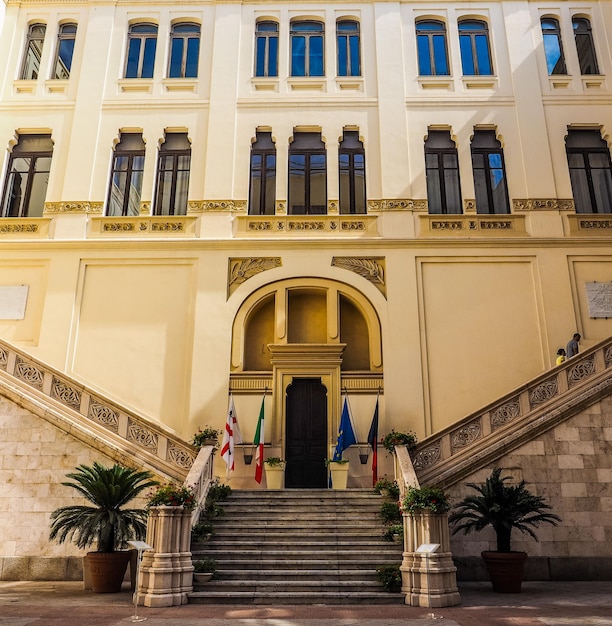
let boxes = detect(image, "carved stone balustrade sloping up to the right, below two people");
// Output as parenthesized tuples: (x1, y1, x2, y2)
(412, 337, 612, 487)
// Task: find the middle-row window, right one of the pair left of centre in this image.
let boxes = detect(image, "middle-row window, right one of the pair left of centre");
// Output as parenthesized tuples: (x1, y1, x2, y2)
(154, 133, 191, 215)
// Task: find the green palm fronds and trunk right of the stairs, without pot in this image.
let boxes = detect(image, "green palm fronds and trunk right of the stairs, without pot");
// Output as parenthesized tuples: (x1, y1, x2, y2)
(449, 467, 561, 552)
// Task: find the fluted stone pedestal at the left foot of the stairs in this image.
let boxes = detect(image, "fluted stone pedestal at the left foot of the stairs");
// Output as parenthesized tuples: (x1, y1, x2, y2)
(138, 506, 193, 607)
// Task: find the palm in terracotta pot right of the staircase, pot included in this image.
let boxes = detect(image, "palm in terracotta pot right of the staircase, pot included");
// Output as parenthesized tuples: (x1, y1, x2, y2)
(449, 467, 561, 593)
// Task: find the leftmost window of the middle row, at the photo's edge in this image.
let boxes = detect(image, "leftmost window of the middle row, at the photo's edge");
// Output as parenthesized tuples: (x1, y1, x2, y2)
(2, 135, 53, 217)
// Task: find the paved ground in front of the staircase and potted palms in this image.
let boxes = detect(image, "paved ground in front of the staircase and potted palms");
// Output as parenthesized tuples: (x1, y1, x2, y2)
(0, 582, 612, 626)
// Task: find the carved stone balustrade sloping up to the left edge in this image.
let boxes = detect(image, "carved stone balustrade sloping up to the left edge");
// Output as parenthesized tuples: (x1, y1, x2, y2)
(0, 340, 196, 482)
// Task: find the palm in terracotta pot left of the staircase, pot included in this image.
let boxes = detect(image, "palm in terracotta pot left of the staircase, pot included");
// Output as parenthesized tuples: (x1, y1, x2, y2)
(49, 462, 157, 593)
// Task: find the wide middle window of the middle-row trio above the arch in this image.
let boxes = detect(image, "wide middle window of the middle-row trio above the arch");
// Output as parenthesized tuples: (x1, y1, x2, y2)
(289, 132, 327, 215)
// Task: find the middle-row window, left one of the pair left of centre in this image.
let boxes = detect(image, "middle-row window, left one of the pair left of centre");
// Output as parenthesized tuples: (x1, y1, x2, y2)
(106, 133, 145, 215)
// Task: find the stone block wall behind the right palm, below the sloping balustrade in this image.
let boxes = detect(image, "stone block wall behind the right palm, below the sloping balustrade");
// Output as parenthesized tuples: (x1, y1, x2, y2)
(448, 397, 612, 580)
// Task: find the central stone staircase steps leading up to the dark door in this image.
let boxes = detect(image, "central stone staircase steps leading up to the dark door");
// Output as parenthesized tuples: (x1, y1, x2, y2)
(189, 489, 404, 604)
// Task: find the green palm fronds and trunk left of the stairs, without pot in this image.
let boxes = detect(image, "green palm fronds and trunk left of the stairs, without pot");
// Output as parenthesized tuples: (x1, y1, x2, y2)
(49, 462, 157, 552)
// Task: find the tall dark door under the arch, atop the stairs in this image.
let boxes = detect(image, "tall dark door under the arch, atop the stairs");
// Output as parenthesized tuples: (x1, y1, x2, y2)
(285, 378, 327, 489)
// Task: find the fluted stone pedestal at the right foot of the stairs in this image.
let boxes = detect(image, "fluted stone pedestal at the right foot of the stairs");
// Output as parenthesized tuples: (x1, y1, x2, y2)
(400, 513, 461, 608)
